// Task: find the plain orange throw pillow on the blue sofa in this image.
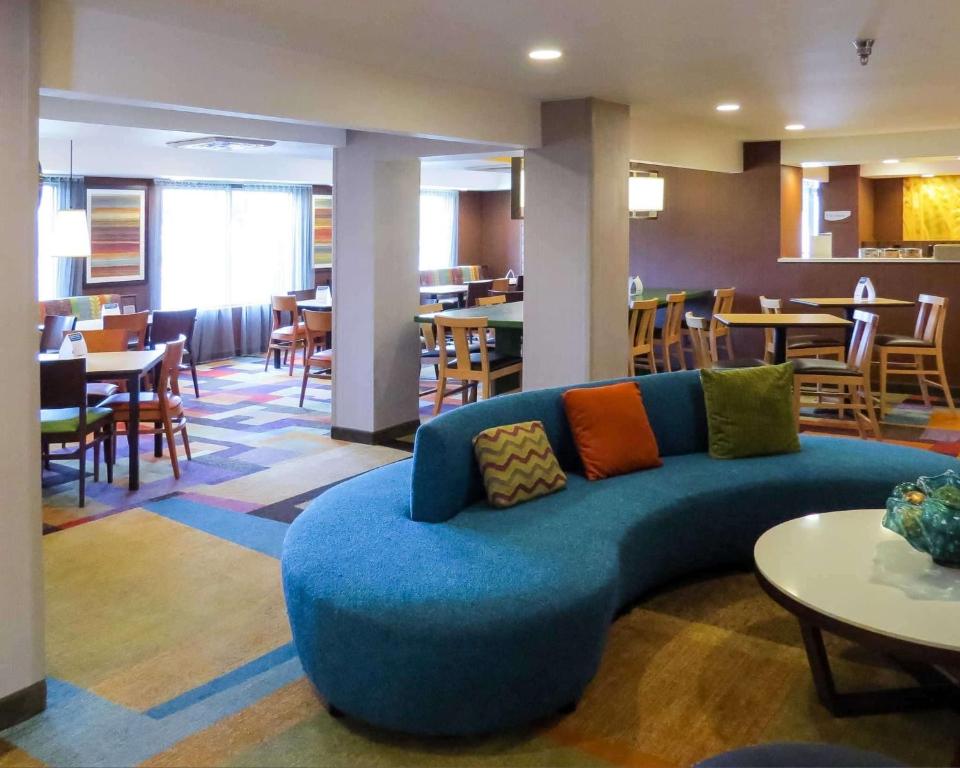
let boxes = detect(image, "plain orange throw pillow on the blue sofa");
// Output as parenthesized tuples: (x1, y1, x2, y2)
(563, 381, 663, 480)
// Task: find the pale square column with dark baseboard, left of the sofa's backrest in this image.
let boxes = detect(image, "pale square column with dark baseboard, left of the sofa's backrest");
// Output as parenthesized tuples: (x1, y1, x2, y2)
(332, 131, 420, 442)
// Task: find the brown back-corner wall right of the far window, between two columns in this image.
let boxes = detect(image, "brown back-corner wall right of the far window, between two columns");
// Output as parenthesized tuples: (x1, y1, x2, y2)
(457, 190, 523, 277)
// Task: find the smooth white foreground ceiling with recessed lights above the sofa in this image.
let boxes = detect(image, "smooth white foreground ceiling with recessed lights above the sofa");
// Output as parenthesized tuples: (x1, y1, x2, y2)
(75, 0, 960, 140)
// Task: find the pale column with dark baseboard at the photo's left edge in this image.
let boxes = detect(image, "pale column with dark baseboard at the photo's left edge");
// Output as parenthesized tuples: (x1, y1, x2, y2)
(0, 0, 45, 728)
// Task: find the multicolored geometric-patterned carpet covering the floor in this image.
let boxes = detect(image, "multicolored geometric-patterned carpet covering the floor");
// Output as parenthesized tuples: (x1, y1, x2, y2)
(0, 358, 960, 766)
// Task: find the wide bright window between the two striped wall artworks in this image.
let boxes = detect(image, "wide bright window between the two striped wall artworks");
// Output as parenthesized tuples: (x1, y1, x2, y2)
(160, 185, 300, 309)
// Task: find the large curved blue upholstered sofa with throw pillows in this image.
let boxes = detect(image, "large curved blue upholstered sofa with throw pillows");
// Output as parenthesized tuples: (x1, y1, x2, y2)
(282, 372, 960, 734)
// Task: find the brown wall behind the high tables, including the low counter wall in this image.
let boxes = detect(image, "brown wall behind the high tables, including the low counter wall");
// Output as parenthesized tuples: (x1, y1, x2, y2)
(630, 142, 960, 385)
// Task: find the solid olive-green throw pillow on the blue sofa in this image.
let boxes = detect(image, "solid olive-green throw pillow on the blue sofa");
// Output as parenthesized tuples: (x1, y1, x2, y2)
(700, 363, 800, 459)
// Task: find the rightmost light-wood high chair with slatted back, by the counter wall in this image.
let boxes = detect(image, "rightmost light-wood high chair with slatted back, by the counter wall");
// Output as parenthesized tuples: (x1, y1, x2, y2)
(877, 293, 956, 419)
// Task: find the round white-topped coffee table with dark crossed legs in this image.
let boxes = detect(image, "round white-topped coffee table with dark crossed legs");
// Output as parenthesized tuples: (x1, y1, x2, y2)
(753, 509, 960, 716)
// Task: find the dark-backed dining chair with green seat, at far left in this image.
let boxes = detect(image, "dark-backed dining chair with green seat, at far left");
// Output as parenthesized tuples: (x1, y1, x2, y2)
(40, 357, 116, 508)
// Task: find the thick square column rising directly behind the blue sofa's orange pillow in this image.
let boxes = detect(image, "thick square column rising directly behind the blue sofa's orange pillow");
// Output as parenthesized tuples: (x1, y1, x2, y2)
(523, 99, 630, 389)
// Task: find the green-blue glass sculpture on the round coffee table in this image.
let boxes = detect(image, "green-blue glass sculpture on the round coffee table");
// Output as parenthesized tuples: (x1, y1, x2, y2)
(883, 469, 960, 568)
